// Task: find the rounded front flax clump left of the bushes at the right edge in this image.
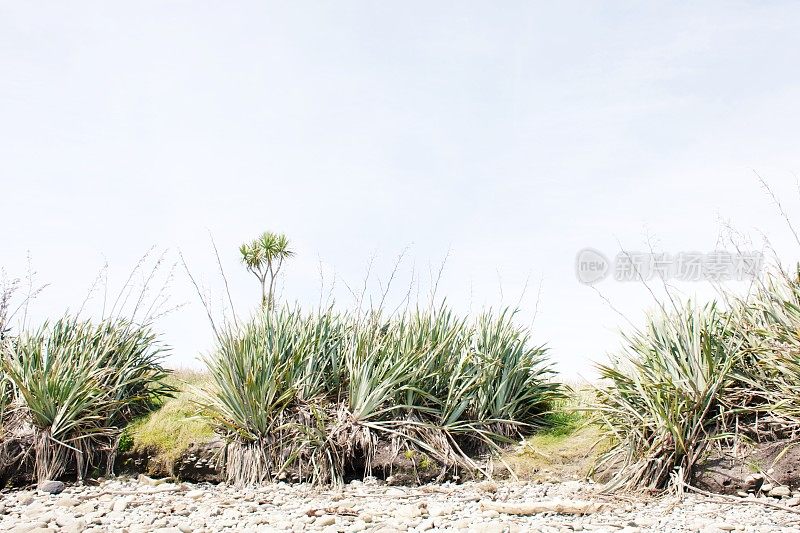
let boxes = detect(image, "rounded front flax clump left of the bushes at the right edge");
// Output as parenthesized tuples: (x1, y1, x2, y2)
(595, 303, 740, 489)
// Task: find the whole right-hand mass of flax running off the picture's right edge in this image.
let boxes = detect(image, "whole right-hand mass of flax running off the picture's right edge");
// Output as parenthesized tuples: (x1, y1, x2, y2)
(592, 271, 800, 489)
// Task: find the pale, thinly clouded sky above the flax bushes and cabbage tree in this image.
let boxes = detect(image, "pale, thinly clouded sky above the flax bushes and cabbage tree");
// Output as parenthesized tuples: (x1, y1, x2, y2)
(0, 1, 800, 378)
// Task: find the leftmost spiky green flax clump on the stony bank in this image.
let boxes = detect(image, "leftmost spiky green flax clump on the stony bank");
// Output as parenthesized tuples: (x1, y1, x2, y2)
(2, 317, 172, 481)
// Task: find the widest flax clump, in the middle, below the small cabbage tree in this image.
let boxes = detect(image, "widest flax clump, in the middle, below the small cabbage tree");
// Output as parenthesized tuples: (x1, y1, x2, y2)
(201, 306, 562, 484)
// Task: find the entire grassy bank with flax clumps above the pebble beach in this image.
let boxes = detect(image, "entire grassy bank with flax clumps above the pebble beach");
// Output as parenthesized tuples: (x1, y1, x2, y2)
(9, 256, 800, 490)
